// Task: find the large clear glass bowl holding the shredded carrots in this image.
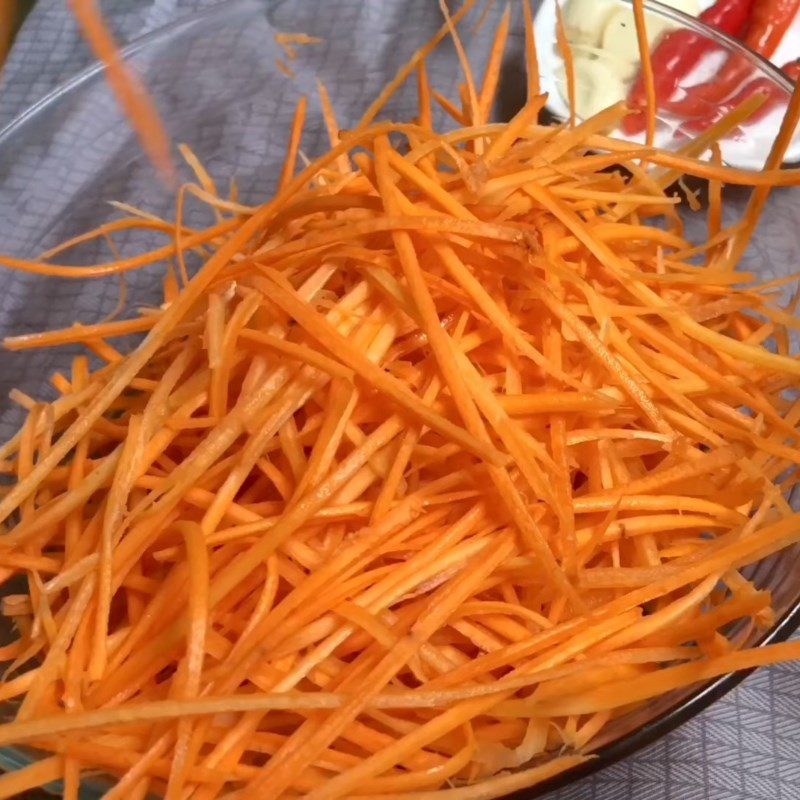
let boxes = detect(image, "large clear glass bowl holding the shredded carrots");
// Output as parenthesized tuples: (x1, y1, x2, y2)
(0, 0, 800, 798)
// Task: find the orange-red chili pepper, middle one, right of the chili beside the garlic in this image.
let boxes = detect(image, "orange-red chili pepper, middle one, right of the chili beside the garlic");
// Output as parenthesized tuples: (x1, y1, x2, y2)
(669, 0, 800, 117)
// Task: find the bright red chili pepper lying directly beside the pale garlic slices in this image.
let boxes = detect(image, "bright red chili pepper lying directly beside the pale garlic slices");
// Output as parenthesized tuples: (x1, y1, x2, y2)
(622, 0, 756, 134)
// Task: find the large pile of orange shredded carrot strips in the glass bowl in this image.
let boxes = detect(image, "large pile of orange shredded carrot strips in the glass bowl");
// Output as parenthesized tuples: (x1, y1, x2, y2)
(0, 4, 800, 800)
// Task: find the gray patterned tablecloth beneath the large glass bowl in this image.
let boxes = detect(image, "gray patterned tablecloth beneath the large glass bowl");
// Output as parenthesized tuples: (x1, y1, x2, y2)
(0, 0, 800, 800)
